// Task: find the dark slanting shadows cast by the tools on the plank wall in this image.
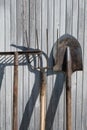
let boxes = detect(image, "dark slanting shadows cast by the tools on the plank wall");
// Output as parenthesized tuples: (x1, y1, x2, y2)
(0, 45, 65, 130)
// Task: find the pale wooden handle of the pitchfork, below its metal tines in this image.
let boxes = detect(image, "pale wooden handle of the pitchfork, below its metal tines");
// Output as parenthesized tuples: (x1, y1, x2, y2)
(40, 71, 46, 130)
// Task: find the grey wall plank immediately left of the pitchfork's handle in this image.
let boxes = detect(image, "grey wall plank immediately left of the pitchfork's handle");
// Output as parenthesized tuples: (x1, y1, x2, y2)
(34, 0, 41, 130)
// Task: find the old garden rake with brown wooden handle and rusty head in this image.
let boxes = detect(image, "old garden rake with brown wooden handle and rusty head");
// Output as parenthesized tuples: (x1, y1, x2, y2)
(11, 49, 42, 130)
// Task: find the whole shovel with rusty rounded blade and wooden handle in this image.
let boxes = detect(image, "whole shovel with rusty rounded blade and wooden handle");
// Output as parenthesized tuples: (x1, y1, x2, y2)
(53, 34, 83, 130)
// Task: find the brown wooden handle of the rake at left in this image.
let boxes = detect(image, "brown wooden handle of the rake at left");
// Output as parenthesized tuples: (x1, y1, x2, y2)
(13, 52, 18, 130)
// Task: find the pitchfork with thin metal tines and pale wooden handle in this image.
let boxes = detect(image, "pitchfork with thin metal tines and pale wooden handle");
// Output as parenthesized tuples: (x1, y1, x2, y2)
(29, 30, 48, 130)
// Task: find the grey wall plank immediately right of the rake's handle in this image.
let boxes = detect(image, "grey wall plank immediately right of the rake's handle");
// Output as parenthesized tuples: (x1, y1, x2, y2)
(15, 0, 24, 128)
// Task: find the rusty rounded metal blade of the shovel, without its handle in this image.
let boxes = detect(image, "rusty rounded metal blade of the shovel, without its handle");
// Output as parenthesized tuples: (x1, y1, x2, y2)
(53, 34, 83, 72)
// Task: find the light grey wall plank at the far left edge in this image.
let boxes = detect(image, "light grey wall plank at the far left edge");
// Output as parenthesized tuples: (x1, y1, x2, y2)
(0, 0, 6, 130)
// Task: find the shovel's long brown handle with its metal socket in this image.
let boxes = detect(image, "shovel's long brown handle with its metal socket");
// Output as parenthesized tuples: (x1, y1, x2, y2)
(66, 47, 72, 130)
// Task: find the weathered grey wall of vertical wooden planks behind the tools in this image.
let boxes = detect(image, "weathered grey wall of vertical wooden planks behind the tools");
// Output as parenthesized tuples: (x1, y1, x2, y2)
(0, 0, 87, 130)
